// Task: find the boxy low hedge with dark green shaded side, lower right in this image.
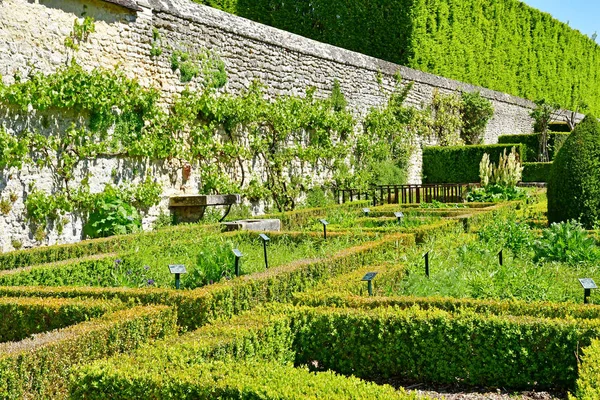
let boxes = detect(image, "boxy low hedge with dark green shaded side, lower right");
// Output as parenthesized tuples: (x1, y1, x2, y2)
(292, 308, 600, 390)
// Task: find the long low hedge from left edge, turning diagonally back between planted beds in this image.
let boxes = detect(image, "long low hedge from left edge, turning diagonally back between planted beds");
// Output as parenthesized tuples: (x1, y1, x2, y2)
(0, 233, 418, 329)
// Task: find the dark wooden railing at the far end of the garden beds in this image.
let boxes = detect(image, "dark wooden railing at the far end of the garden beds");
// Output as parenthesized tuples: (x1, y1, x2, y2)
(337, 183, 473, 205)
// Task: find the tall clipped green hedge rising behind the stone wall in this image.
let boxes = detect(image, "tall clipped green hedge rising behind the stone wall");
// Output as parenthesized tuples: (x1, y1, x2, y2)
(194, 0, 600, 112)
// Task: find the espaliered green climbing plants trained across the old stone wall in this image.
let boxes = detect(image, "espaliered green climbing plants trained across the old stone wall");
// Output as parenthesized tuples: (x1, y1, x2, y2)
(0, 52, 492, 238)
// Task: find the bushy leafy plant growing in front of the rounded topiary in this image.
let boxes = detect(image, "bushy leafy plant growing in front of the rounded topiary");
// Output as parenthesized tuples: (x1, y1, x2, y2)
(533, 221, 600, 264)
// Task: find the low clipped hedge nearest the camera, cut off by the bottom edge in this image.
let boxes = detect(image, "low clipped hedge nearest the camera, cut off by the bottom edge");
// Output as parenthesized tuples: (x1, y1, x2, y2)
(71, 361, 427, 400)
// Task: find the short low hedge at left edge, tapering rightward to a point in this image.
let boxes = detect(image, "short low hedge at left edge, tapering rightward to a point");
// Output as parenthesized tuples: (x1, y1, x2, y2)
(0, 297, 124, 343)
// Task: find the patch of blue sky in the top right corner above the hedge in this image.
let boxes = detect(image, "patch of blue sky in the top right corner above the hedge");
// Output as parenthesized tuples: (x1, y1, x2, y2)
(523, 0, 600, 43)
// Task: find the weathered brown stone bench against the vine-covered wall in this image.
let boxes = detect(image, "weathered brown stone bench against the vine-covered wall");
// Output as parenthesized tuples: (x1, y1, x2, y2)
(169, 194, 242, 223)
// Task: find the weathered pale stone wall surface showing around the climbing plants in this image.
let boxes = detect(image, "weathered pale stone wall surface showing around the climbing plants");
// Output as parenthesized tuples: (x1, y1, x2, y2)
(0, 0, 552, 251)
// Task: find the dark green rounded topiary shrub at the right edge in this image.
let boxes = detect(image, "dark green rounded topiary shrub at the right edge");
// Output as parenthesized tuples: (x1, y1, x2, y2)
(548, 115, 600, 229)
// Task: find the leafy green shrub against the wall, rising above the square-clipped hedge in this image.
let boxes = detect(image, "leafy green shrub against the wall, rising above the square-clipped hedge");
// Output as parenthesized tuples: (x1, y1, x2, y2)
(461, 92, 494, 144)
